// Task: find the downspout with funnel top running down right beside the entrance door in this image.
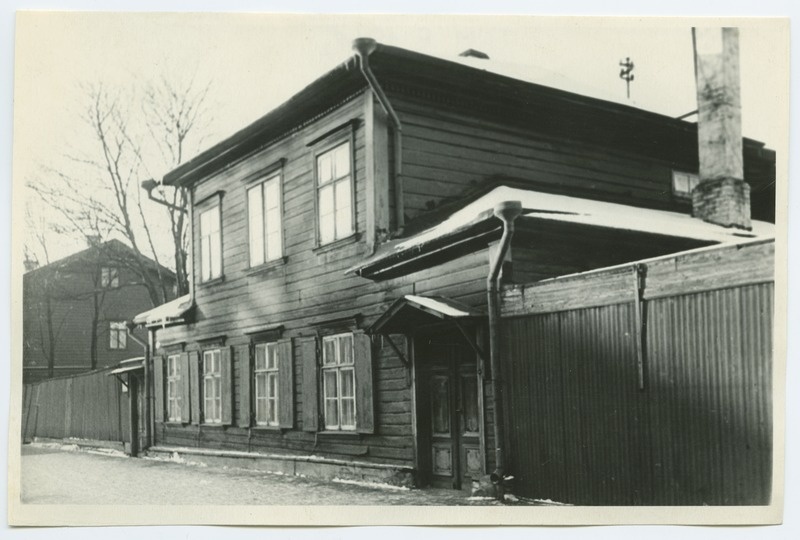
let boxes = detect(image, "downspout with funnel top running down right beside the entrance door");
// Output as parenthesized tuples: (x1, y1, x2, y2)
(486, 201, 522, 491)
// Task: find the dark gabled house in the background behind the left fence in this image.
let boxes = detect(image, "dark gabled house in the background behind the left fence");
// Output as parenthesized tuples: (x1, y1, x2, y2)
(22, 240, 175, 383)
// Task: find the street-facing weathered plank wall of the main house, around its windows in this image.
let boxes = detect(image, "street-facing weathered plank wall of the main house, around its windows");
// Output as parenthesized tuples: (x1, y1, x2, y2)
(156, 92, 496, 466)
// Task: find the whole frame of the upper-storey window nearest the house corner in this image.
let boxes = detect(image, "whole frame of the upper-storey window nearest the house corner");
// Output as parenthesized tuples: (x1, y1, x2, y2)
(313, 133, 358, 247)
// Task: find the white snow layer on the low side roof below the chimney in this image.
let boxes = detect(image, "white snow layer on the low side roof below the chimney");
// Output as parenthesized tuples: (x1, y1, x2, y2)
(394, 186, 775, 252)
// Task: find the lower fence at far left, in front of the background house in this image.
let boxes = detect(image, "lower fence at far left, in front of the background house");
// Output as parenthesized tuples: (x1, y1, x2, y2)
(22, 370, 130, 443)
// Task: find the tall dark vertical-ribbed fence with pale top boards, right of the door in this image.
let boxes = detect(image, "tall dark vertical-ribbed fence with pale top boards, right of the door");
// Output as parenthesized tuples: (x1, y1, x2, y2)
(503, 242, 774, 505)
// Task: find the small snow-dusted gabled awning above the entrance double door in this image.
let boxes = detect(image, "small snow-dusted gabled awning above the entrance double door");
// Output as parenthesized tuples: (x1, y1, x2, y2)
(368, 294, 485, 334)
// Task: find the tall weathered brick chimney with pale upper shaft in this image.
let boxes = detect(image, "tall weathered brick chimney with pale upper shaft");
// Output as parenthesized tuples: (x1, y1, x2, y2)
(692, 27, 750, 229)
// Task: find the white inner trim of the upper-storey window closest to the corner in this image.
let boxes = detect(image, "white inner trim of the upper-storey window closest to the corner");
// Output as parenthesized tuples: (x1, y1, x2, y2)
(314, 138, 357, 246)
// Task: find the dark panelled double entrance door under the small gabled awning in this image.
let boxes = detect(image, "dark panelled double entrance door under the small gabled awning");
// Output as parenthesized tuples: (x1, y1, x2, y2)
(419, 345, 483, 489)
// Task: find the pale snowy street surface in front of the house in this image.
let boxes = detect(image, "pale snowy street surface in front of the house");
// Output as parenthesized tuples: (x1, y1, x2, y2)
(21, 445, 528, 506)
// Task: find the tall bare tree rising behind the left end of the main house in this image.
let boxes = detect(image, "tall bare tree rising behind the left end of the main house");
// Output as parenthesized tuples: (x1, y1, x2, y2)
(29, 73, 210, 305)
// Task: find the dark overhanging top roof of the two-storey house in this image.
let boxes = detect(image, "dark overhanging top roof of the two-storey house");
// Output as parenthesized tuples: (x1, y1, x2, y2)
(163, 43, 774, 189)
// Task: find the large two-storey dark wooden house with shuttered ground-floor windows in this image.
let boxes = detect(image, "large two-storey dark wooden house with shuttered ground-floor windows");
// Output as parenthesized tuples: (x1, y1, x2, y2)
(136, 40, 775, 498)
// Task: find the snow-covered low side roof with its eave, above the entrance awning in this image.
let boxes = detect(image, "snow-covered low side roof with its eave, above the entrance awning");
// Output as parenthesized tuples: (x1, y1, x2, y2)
(348, 186, 775, 279)
